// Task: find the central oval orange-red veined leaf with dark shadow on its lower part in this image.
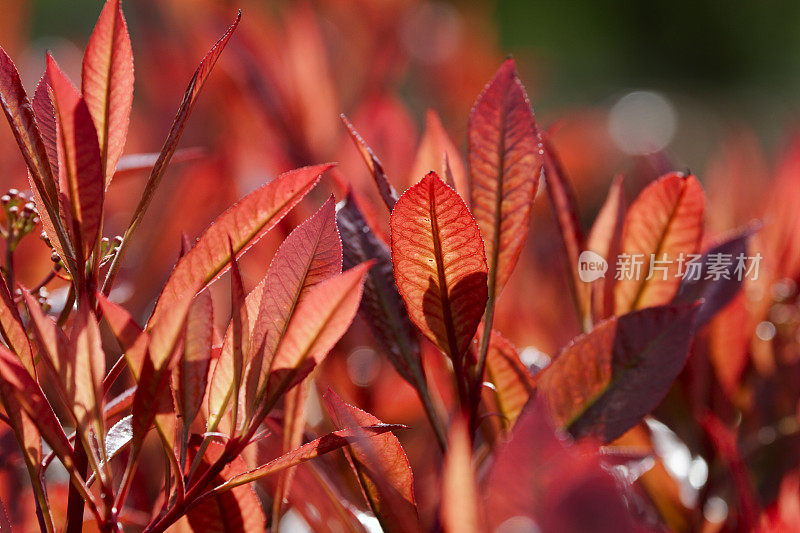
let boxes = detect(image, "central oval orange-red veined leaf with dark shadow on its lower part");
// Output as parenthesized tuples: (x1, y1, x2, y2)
(391, 172, 487, 360)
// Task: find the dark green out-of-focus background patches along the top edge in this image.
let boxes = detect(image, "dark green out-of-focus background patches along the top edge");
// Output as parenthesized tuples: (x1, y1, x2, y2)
(17, 0, 800, 168)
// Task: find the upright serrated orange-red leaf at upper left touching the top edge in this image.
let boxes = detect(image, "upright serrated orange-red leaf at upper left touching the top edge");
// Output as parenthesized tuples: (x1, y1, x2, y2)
(81, 0, 133, 181)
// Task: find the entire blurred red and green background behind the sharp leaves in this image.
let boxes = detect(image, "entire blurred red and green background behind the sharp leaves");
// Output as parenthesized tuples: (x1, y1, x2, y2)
(0, 0, 800, 531)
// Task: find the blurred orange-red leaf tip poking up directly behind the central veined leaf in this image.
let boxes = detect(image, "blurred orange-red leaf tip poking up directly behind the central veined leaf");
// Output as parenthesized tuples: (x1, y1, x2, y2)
(411, 109, 469, 199)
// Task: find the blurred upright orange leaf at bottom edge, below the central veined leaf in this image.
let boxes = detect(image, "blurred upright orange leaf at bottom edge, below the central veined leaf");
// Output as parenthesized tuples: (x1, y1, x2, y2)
(441, 418, 482, 533)
